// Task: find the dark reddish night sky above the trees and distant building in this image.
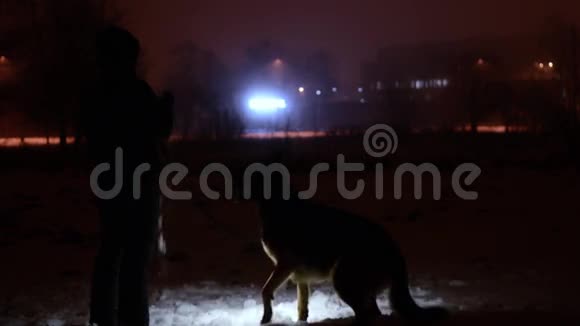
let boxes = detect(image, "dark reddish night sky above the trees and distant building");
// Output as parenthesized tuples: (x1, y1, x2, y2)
(117, 0, 580, 88)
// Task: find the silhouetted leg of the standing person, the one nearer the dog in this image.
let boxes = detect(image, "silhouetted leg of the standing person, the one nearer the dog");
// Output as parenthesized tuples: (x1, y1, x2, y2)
(119, 188, 159, 326)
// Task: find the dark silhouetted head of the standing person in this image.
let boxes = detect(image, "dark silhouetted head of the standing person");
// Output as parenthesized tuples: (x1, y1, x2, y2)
(97, 26, 140, 78)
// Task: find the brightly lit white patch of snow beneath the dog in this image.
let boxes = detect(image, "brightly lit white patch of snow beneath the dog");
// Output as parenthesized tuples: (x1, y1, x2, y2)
(151, 284, 442, 326)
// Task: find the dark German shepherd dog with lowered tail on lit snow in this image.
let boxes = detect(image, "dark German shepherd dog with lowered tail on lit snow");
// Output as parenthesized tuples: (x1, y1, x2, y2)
(258, 182, 447, 325)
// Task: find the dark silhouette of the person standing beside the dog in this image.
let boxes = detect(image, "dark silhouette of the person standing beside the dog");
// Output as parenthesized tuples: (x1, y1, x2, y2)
(83, 27, 172, 326)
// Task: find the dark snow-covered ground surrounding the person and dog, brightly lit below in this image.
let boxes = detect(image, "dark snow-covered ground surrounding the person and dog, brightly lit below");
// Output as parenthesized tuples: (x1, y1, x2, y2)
(0, 134, 580, 326)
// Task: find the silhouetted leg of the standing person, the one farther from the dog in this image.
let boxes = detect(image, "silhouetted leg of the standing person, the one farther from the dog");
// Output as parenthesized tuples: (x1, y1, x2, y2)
(90, 202, 123, 326)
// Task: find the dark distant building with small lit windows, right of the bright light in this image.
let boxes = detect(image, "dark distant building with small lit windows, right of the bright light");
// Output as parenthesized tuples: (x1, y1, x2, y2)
(361, 37, 562, 130)
